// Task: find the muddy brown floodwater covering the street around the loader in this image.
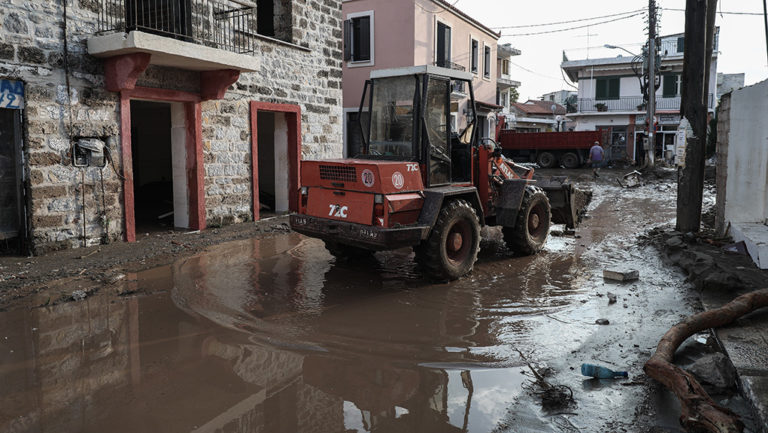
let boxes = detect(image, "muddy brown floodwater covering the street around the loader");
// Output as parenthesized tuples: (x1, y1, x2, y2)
(0, 184, 712, 433)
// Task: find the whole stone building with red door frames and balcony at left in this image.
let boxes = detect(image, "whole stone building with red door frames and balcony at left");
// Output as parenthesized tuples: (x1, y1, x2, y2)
(0, 0, 342, 253)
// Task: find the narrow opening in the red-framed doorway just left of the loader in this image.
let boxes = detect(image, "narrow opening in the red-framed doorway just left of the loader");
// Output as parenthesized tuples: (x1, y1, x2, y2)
(257, 111, 290, 218)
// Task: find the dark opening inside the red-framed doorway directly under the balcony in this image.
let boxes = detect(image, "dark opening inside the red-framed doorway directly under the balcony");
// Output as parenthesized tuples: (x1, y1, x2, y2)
(131, 101, 174, 232)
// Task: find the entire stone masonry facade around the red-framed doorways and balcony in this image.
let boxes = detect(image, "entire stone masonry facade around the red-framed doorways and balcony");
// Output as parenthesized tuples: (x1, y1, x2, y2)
(0, 0, 342, 253)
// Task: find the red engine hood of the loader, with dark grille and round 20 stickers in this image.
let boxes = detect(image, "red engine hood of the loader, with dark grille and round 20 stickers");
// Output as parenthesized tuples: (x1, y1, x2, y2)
(301, 159, 424, 194)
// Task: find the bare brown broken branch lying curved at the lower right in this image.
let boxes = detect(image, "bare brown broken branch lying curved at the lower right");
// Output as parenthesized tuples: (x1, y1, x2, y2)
(643, 289, 768, 433)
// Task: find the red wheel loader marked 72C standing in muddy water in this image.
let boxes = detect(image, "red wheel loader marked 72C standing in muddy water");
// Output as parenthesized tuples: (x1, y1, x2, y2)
(291, 66, 576, 280)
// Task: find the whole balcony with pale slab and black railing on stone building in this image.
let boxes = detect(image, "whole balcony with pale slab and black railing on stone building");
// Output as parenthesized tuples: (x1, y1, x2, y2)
(88, 0, 292, 76)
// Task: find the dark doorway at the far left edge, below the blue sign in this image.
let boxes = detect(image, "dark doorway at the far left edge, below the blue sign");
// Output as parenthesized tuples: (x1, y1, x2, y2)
(0, 108, 26, 254)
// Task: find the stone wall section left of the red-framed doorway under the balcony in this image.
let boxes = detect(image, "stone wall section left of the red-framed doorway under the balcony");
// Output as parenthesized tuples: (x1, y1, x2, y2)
(0, 0, 123, 252)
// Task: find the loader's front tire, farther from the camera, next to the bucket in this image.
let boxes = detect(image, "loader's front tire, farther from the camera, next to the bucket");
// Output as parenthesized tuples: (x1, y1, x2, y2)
(502, 186, 552, 256)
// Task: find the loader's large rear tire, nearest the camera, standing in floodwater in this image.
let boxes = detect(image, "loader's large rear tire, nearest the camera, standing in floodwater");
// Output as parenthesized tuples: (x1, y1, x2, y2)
(415, 200, 480, 281)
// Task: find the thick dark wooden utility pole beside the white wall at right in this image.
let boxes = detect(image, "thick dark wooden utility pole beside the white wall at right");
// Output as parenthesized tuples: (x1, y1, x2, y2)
(677, 0, 717, 232)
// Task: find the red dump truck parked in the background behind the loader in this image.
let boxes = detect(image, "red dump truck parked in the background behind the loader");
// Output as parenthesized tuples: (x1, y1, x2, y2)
(496, 120, 605, 168)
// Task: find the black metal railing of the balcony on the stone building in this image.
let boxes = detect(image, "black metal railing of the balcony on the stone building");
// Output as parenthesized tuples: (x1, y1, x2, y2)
(98, 0, 257, 53)
